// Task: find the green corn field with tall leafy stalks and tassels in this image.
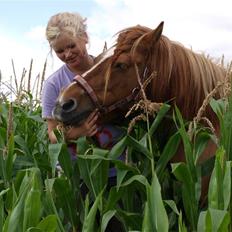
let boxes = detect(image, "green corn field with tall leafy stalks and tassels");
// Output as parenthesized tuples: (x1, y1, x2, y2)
(0, 60, 232, 232)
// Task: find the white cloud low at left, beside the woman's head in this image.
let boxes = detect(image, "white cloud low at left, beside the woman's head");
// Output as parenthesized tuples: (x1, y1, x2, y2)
(0, 26, 61, 87)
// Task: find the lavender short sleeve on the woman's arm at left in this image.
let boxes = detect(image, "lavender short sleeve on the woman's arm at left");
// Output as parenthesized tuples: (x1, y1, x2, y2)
(41, 81, 59, 119)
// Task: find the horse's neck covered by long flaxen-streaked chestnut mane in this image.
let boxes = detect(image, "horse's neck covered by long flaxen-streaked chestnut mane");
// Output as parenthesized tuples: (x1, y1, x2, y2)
(147, 36, 225, 119)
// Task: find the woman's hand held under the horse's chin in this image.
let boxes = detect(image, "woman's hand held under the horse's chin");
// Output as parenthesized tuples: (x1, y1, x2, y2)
(65, 110, 99, 140)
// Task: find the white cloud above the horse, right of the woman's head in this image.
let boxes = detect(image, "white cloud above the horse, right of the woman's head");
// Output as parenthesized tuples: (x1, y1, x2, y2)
(88, 0, 232, 63)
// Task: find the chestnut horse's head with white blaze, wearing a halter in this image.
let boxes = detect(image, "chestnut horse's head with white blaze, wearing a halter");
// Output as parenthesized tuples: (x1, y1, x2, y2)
(53, 22, 163, 124)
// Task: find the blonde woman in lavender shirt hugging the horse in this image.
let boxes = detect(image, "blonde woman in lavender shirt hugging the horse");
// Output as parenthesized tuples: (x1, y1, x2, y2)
(42, 12, 125, 160)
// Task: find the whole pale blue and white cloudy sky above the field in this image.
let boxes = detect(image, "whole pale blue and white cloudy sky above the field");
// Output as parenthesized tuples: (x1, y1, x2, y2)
(0, 0, 232, 93)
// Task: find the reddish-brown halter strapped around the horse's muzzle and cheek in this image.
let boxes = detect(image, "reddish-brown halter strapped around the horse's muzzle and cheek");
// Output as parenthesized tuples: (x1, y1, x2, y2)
(73, 75, 140, 114)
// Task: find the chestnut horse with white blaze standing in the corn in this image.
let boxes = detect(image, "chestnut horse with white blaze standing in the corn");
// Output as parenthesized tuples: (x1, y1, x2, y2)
(54, 22, 226, 163)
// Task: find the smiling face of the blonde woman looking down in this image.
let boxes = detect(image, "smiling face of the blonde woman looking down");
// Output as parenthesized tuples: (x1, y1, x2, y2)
(52, 34, 87, 69)
